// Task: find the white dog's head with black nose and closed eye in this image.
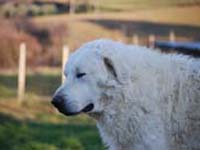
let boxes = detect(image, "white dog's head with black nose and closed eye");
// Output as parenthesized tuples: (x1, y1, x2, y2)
(52, 40, 119, 115)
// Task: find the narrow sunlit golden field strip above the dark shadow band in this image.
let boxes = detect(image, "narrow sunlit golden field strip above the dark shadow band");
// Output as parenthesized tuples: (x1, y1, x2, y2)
(33, 6, 200, 26)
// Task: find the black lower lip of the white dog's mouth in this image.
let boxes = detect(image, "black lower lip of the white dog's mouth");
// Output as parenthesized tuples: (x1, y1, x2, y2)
(58, 103, 94, 116)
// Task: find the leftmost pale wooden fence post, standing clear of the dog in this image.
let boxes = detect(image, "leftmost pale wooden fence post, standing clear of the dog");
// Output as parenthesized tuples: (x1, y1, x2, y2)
(18, 43, 26, 104)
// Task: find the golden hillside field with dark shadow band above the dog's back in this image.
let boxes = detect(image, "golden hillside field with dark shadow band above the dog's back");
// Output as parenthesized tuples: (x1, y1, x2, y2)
(33, 6, 200, 49)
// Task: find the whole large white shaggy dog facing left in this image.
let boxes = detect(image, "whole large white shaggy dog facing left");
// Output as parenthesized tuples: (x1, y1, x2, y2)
(52, 40, 200, 150)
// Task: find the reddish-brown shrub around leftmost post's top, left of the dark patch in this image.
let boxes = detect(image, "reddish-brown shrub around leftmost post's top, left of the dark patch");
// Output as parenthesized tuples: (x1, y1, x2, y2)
(0, 18, 41, 68)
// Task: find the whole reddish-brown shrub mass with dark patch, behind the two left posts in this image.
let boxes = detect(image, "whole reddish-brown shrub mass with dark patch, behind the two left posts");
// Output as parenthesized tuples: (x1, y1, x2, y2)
(0, 14, 68, 68)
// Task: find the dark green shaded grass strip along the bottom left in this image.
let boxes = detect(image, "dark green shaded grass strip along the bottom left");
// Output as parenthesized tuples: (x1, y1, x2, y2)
(0, 113, 104, 150)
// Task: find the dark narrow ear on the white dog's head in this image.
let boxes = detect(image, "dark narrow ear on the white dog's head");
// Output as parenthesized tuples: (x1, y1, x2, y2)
(103, 57, 117, 79)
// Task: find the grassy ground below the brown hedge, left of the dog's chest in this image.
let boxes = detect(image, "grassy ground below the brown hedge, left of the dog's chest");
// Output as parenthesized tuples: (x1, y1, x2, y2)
(0, 72, 104, 150)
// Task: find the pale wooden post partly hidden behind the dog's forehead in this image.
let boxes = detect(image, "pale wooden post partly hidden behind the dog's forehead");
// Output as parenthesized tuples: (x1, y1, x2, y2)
(62, 45, 69, 83)
